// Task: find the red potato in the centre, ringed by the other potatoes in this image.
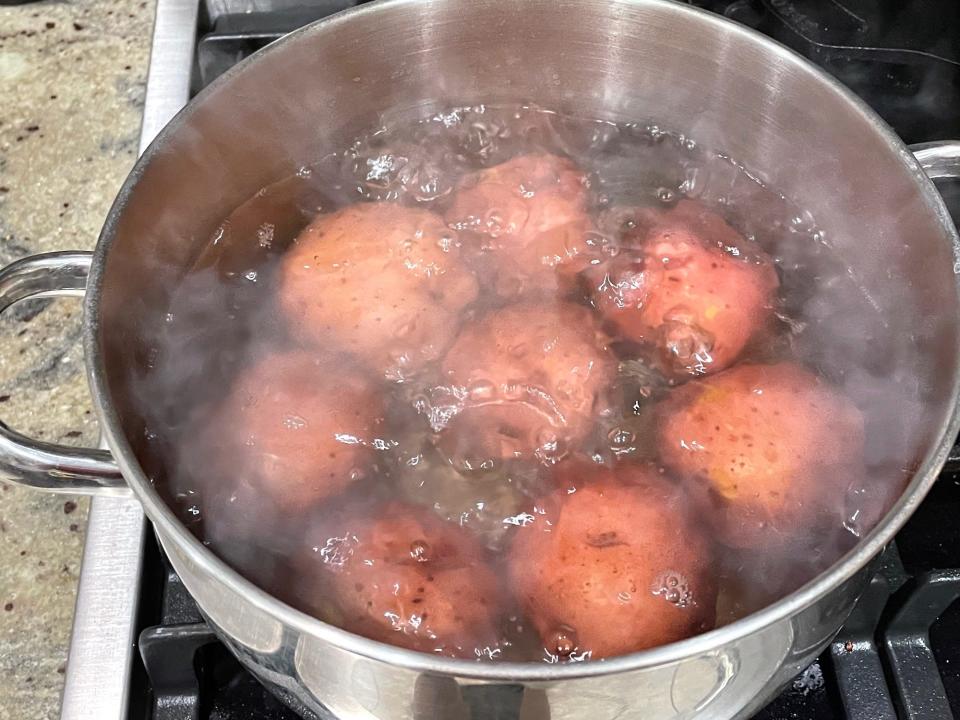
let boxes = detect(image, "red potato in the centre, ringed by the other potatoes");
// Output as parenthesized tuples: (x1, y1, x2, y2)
(441, 302, 616, 469)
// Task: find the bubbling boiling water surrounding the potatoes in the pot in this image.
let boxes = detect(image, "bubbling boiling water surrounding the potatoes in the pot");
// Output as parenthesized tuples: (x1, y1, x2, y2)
(140, 106, 907, 661)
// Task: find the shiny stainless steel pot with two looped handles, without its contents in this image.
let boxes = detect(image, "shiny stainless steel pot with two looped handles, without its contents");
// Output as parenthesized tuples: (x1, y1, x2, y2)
(0, 0, 960, 720)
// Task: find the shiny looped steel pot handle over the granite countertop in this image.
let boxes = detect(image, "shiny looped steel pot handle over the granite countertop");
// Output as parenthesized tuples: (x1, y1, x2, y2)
(0, 252, 130, 495)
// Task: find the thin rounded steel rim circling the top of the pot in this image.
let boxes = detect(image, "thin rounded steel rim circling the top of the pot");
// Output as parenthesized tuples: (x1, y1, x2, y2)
(83, 0, 960, 682)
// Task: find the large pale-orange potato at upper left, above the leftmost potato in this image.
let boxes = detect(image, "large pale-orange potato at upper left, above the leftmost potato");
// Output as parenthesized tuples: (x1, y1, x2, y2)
(279, 203, 478, 379)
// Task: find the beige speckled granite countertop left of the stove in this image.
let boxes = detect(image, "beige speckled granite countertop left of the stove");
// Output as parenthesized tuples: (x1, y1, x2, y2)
(0, 0, 154, 720)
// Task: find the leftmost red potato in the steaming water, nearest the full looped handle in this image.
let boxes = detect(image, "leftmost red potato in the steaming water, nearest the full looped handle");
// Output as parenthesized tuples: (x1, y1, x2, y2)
(204, 352, 383, 516)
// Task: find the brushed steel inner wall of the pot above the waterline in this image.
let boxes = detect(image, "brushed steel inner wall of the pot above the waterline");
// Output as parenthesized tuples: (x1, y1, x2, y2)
(97, 0, 958, 540)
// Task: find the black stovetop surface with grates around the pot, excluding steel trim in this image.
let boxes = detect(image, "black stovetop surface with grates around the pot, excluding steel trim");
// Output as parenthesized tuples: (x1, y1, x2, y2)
(128, 0, 960, 720)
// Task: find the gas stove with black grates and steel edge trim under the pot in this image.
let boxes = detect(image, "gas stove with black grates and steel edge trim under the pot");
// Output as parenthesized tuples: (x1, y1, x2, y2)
(61, 0, 960, 720)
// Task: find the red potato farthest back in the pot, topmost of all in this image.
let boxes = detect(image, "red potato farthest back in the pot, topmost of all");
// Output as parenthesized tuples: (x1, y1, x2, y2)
(444, 155, 595, 298)
